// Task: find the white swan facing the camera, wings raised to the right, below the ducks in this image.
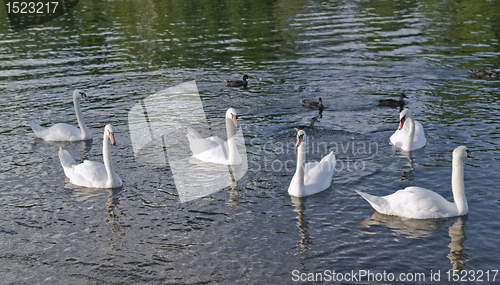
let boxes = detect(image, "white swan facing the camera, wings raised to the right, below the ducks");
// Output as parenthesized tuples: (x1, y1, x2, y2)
(288, 130, 336, 197)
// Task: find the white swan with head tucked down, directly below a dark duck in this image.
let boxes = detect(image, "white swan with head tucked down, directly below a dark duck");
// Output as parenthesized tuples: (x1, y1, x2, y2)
(390, 109, 427, 151)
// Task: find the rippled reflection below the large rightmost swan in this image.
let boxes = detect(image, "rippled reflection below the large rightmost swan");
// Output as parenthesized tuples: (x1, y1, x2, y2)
(361, 212, 469, 271)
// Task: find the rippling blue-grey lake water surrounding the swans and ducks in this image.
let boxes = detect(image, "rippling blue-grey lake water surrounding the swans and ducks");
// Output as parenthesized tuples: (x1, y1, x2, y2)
(0, 0, 500, 284)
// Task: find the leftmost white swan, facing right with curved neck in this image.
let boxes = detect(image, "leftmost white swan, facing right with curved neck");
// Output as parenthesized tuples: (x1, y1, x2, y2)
(30, 90, 92, 141)
